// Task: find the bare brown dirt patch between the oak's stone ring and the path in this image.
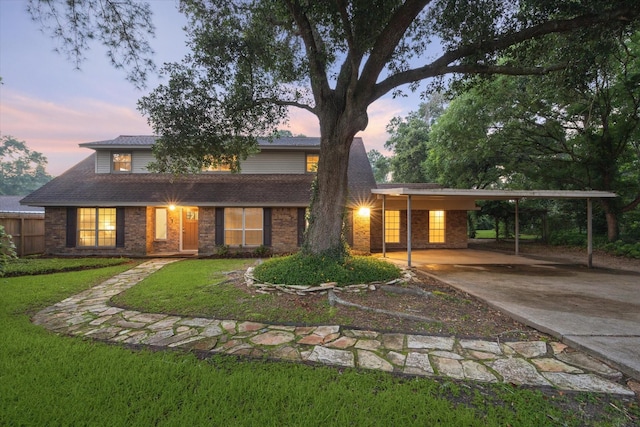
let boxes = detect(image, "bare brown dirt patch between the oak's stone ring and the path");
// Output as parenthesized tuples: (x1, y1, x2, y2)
(224, 274, 545, 340)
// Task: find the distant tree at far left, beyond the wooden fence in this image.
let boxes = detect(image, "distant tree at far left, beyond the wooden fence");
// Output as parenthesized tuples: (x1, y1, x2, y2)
(0, 136, 52, 196)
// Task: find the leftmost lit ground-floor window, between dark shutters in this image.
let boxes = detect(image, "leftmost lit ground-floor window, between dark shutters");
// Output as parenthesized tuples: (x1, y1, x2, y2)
(78, 208, 116, 247)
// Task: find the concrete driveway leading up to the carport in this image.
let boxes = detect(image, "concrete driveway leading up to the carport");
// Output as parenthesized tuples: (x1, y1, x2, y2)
(380, 249, 640, 380)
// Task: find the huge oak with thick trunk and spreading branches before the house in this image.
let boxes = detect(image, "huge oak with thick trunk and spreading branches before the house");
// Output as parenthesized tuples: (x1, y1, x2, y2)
(28, 0, 640, 258)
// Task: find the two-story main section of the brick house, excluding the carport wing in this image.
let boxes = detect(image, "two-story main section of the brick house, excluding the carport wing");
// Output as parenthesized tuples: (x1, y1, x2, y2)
(22, 136, 384, 256)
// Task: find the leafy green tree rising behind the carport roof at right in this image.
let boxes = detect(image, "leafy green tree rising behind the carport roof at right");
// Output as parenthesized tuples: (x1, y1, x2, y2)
(426, 34, 640, 240)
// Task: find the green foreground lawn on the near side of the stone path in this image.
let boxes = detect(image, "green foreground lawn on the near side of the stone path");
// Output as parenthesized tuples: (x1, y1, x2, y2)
(0, 262, 637, 426)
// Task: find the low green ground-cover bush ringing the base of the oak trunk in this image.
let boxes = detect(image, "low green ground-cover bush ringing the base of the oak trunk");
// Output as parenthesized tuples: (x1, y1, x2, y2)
(254, 253, 400, 286)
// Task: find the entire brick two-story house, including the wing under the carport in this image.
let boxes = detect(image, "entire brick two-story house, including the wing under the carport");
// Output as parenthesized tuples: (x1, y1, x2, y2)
(21, 136, 490, 256)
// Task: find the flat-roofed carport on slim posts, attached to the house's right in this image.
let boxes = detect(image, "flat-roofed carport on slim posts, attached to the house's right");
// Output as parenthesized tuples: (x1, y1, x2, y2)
(371, 187, 617, 268)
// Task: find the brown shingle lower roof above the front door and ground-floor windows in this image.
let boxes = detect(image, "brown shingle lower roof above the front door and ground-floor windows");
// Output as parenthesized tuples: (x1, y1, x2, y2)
(21, 137, 375, 207)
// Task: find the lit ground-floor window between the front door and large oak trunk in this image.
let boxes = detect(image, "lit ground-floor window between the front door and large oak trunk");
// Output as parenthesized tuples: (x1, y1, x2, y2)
(224, 208, 263, 246)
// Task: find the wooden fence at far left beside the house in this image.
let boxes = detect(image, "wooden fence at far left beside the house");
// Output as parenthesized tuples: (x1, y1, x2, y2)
(0, 213, 44, 256)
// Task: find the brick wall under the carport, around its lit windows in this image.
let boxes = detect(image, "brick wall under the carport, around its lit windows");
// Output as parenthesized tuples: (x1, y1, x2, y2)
(371, 210, 467, 251)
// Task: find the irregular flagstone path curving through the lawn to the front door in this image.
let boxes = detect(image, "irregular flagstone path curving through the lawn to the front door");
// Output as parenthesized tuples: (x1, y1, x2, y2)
(32, 259, 634, 396)
